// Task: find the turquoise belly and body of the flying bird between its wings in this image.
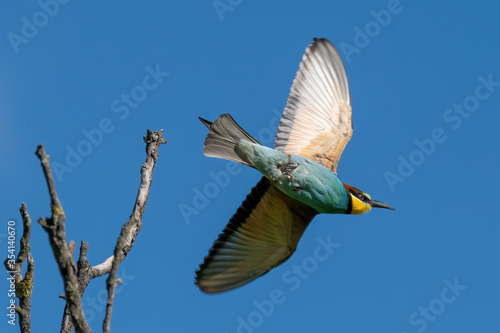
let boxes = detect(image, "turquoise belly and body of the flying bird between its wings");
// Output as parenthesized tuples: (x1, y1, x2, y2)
(240, 140, 348, 214)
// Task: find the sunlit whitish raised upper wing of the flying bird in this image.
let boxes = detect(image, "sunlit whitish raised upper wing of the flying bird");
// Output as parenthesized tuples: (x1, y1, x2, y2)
(274, 38, 352, 172)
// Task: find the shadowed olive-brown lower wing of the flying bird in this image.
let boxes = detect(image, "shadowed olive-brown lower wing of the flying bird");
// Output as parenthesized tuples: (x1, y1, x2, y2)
(195, 177, 317, 293)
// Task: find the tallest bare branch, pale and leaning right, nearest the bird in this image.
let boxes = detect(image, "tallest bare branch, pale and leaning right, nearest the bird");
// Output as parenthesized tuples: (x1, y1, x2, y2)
(103, 130, 167, 333)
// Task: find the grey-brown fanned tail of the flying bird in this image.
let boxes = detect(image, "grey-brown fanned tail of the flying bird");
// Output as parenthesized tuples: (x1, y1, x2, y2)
(198, 113, 260, 168)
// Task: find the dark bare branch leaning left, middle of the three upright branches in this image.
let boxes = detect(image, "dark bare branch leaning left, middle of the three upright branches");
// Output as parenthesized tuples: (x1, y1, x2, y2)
(36, 145, 92, 333)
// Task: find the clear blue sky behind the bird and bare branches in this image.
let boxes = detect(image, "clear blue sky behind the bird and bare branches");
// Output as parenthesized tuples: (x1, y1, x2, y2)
(0, 0, 500, 333)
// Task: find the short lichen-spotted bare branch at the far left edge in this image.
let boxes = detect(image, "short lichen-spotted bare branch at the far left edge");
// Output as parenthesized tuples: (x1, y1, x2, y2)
(4, 202, 35, 333)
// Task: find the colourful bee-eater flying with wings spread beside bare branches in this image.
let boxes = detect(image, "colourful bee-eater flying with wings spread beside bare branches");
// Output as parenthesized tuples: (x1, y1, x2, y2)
(195, 38, 395, 294)
